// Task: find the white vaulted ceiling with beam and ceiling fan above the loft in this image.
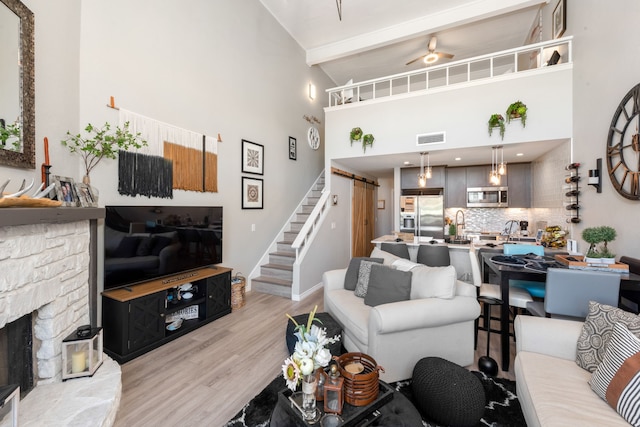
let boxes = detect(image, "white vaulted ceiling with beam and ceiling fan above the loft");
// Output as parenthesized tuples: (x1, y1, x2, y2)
(260, 0, 547, 85)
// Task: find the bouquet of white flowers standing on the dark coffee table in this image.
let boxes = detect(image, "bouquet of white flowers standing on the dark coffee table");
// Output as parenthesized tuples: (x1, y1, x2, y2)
(282, 306, 340, 391)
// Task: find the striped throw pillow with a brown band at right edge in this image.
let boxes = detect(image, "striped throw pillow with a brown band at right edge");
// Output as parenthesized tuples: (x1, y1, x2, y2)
(589, 323, 640, 426)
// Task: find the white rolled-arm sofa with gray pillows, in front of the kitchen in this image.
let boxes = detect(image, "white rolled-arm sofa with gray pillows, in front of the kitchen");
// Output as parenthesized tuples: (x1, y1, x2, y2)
(323, 249, 480, 382)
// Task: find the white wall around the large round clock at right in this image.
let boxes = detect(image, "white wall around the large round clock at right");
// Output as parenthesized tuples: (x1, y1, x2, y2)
(568, 0, 640, 257)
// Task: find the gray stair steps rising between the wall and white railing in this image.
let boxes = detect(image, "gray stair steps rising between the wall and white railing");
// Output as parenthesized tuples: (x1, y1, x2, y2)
(251, 175, 324, 298)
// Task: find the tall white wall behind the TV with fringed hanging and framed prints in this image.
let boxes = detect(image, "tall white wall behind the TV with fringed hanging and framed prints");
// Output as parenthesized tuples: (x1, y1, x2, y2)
(0, 0, 333, 290)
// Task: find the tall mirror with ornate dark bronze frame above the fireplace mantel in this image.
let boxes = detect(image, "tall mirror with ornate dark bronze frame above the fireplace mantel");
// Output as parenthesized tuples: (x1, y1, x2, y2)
(0, 0, 36, 169)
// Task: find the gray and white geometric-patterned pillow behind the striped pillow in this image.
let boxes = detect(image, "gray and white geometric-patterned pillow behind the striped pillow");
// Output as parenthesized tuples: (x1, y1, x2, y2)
(576, 301, 640, 372)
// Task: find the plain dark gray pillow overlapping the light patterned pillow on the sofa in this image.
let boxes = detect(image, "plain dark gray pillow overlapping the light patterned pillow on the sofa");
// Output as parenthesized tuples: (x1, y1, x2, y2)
(364, 264, 412, 307)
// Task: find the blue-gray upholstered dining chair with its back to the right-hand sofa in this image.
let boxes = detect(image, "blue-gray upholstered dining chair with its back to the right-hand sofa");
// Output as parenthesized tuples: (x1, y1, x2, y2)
(527, 268, 620, 320)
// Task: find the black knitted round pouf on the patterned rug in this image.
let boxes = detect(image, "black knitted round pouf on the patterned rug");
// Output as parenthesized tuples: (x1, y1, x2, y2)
(412, 357, 486, 426)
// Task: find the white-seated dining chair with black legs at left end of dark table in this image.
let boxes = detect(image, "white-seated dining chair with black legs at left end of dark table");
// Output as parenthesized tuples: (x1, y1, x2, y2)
(469, 245, 533, 343)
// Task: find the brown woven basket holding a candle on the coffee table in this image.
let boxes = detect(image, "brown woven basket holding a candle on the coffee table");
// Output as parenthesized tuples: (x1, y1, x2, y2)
(336, 353, 384, 406)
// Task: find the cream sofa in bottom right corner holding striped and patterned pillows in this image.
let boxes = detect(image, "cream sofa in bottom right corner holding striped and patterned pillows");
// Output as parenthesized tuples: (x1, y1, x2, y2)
(514, 316, 629, 427)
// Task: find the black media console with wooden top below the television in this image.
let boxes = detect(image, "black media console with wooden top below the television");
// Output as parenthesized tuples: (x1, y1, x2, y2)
(102, 267, 231, 363)
